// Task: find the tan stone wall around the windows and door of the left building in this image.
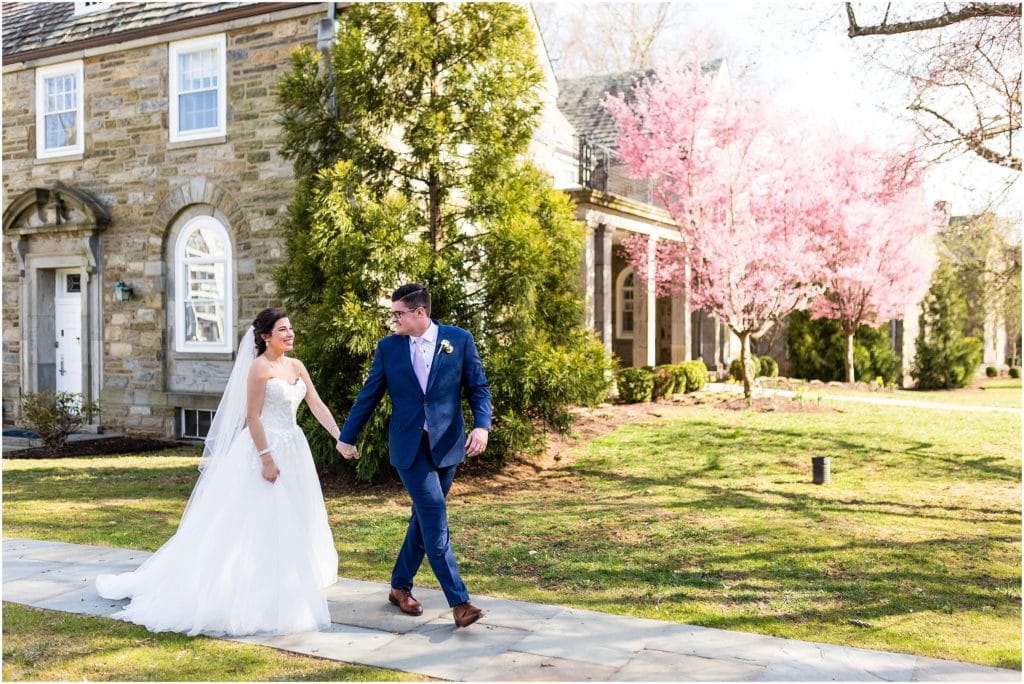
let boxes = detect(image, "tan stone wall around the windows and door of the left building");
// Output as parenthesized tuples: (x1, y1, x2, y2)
(3, 7, 321, 436)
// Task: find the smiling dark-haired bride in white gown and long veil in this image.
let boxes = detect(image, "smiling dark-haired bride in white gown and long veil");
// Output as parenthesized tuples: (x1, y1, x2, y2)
(96, 308, 338, 636)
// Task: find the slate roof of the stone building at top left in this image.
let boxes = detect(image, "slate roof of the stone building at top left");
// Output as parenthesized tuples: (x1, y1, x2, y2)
(3, 2, 313, 63)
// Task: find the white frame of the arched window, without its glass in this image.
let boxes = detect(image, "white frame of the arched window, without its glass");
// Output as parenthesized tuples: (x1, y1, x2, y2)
(174, 216, 234, 353)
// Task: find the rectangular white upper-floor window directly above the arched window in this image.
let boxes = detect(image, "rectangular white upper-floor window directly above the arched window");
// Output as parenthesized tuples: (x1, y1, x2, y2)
(169, 35, 226, 142)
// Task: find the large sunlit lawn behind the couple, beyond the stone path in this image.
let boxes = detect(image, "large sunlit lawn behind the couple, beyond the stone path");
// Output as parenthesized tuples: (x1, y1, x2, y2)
(3, 403, 1021, 669)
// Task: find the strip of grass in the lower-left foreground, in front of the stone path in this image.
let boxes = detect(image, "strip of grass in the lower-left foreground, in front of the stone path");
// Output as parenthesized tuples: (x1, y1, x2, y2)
(3, 603, 424, 682)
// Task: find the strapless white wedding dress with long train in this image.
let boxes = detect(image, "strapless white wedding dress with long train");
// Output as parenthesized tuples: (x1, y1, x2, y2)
(96, 378, 338, 636)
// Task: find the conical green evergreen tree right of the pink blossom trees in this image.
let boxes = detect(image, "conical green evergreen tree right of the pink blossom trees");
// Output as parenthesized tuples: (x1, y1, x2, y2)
(910, 261, 982, 389)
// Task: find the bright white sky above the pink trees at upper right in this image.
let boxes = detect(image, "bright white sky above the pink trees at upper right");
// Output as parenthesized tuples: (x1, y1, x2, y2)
(546, 1, 1020, 216)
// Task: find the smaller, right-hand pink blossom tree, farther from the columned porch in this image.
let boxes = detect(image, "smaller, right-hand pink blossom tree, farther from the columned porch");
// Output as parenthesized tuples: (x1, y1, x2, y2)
(811, 141, 941, 382)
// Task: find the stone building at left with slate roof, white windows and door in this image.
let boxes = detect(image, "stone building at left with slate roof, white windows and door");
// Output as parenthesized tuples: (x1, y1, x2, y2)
(3, 2, 330, 437)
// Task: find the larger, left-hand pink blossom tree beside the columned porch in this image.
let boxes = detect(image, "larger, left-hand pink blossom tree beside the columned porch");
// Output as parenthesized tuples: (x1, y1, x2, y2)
(605, 59, 827, 398)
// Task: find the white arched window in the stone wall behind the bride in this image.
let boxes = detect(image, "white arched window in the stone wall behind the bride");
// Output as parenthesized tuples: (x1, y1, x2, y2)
(174, 216, 234, 353)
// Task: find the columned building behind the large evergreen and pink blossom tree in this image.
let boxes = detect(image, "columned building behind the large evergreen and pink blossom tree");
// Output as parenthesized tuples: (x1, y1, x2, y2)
(558, 62, 739, 374)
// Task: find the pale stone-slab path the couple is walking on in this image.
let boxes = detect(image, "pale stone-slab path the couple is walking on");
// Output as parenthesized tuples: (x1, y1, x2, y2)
(3, 539, 1021, 682)
